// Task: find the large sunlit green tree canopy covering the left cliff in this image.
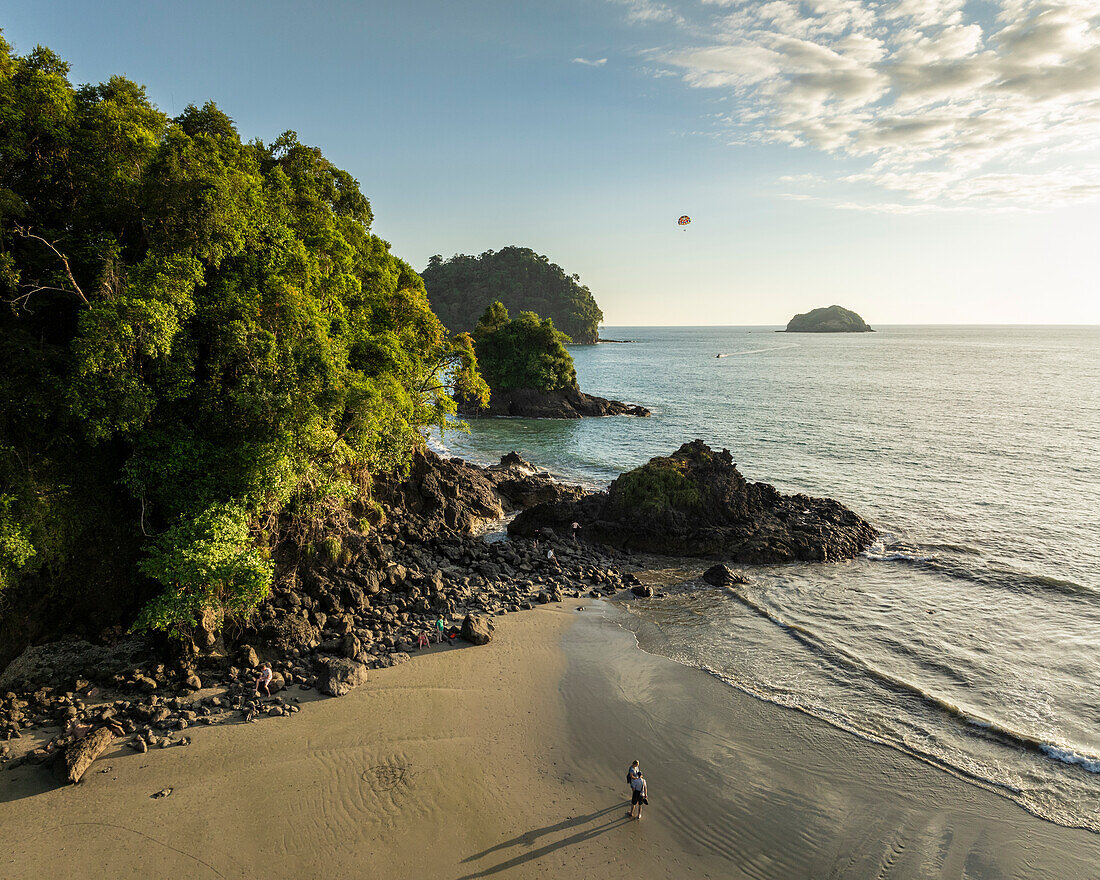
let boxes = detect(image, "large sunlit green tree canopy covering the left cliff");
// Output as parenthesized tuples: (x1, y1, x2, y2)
(0, 39, 487, 631)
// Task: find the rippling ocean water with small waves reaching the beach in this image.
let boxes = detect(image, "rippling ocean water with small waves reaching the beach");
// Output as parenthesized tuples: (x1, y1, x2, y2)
(433, 327, 1100, 832)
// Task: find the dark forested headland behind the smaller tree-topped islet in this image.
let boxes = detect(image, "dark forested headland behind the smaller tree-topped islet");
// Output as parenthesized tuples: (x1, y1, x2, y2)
(420, 246, 604, 344)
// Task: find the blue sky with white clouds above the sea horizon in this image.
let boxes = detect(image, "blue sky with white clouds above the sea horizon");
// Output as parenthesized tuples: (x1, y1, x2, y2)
(0, 0, 1100, 326)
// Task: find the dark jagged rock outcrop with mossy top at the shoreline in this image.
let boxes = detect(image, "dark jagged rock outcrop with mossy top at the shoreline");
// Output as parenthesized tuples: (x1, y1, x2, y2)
(508, 440, 876, 563)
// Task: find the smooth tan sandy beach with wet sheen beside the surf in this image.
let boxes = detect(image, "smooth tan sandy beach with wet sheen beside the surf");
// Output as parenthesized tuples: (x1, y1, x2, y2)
(0, 602, 1100, 880)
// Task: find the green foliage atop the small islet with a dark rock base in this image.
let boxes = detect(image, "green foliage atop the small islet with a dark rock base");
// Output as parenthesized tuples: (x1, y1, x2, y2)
(464, 303, 576, 392)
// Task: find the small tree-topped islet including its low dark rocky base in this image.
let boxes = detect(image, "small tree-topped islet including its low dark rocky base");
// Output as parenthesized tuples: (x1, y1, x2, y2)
(457, 303, 649, 419)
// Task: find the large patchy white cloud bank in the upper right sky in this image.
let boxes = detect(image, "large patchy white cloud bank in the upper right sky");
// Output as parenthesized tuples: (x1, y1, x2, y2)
(613, 0, 1100, 207)
